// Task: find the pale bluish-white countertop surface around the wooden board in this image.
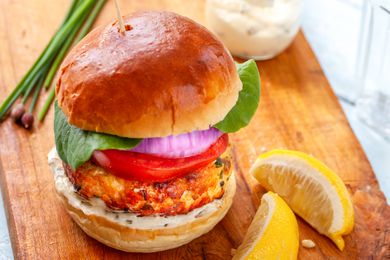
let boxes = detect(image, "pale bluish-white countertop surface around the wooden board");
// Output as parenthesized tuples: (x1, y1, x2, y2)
(0, 0, 390, 260)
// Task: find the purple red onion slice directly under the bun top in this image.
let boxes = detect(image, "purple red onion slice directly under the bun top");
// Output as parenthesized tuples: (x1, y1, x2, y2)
(130, 128, 222, 158)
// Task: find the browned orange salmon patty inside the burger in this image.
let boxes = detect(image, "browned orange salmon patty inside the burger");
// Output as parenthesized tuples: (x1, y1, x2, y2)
(64, 151, 232, 216)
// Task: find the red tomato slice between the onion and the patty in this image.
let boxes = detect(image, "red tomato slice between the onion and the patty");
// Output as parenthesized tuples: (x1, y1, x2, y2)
(92, 134, 229, 182)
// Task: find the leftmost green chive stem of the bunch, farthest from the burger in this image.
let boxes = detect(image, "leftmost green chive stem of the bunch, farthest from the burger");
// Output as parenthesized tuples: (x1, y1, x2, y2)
(0, 0, 94, 120)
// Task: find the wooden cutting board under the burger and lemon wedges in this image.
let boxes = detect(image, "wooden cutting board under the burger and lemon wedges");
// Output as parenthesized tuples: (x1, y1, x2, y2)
(0, 0, 390, 259)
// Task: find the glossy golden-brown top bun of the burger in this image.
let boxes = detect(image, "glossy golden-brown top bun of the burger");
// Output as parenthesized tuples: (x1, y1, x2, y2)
(56, 11, 242, 138)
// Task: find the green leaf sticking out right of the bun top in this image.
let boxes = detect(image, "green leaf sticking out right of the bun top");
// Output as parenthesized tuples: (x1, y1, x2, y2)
(215, 60, 260, 133)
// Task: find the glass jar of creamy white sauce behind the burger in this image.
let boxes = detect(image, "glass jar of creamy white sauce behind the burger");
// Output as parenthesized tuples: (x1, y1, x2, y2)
(206, 0, 301, 60)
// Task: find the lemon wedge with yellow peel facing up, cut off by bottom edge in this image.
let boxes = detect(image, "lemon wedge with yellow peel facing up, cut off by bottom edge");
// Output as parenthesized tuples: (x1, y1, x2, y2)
(233, 192, 299, 260)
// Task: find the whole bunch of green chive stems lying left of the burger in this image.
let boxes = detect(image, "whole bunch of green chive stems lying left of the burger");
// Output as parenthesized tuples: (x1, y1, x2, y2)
(0, 0, 106, 121)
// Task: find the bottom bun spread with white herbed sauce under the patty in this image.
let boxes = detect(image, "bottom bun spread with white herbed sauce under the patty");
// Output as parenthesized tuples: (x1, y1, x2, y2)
(48, 149, 236, 253)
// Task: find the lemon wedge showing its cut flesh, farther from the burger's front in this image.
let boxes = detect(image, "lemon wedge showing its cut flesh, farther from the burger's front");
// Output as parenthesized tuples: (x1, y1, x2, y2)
(250, 150, 354, 250)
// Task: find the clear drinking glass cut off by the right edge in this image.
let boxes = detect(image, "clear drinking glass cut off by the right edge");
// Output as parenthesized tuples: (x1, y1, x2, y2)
(356, 0, 390, 140)
